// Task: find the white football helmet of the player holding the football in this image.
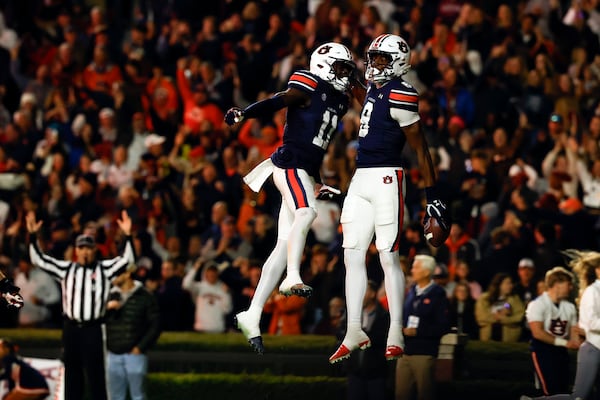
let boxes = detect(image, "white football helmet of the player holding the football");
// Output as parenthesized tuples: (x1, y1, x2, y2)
(365, 34, 410, 83)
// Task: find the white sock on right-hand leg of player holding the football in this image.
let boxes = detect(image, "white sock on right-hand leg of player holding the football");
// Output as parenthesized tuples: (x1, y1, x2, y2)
(379, 251, 405, 345)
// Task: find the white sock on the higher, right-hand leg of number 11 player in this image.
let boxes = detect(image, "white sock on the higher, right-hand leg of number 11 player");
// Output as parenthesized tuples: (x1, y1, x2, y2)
(286, 207, 317, 284)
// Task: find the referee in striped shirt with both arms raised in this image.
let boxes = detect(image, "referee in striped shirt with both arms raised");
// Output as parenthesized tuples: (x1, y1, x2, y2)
(26, 211, 134, 400)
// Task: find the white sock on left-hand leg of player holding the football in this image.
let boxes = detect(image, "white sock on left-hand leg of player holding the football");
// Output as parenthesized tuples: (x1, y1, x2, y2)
(344, 249, 367, 328)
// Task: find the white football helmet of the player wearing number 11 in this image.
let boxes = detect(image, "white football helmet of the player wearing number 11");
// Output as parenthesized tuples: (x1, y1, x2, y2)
(310, 42, 356, 92)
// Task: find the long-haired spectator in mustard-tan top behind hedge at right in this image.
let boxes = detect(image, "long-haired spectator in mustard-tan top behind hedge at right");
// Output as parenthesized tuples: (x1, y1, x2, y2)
(475, 273, 525, 342)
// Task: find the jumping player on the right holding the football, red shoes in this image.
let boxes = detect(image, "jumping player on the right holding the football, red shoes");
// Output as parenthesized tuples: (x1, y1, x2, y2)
(329, 34, 448, 363)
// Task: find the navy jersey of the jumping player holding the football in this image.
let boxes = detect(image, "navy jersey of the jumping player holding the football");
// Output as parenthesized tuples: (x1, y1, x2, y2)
(356, 79, 420, 168)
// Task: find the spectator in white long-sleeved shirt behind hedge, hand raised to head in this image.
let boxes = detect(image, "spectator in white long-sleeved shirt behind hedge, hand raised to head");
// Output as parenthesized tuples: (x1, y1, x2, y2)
(182, 261, 232, 333)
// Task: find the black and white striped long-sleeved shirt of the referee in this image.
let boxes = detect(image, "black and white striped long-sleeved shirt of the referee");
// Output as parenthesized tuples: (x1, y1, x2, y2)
(29, 237, 135, 322)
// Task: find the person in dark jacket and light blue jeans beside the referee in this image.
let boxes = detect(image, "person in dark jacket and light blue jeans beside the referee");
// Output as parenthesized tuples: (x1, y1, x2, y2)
(106, 264, 160, 400)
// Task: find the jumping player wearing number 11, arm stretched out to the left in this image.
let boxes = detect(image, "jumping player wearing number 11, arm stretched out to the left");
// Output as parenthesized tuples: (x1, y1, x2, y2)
(225, 42, 356, 354)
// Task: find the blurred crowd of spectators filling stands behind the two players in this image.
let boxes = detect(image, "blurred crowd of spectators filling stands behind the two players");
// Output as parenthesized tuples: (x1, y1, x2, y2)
(0, 0, 600, 340)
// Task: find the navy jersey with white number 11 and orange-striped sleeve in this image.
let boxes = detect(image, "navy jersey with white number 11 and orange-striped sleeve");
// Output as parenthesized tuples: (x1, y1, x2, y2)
(271, 70, 349, 182)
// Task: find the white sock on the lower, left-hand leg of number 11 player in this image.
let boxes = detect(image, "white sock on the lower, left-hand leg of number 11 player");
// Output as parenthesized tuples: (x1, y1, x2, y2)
(248, 240, 287, 316)
